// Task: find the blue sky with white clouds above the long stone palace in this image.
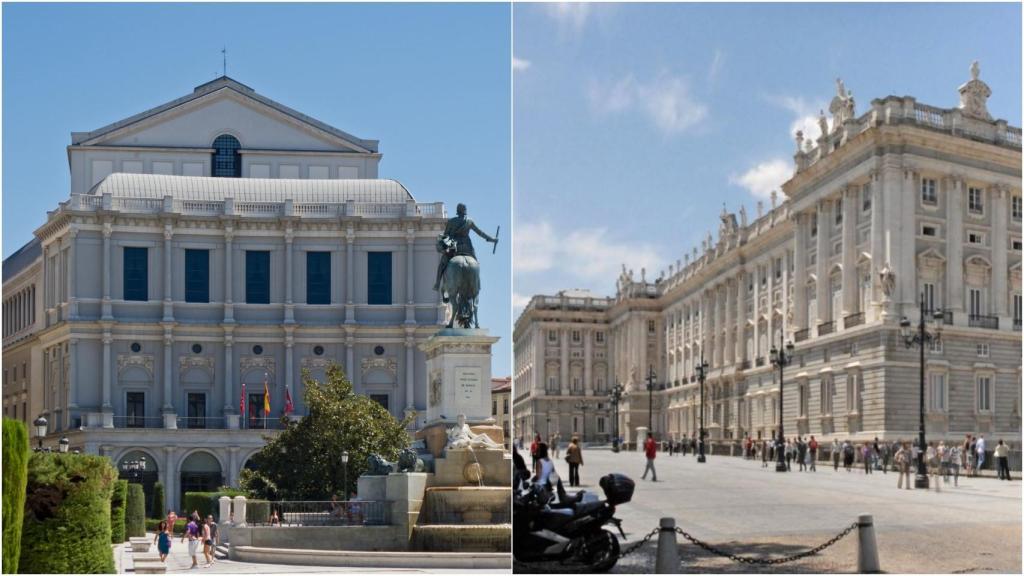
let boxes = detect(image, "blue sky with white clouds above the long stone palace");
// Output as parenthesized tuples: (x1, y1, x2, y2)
(513, 3, 1021, 314)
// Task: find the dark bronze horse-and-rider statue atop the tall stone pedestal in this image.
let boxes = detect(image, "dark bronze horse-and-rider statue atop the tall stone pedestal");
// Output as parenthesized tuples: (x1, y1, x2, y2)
(434, 203, 502, 328)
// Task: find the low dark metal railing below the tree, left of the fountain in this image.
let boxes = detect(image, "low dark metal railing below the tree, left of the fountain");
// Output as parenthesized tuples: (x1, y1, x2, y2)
(249, 500, 389, 527)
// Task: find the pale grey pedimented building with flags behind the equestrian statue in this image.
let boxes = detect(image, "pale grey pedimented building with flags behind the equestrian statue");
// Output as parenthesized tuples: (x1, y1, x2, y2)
(3, 77, 445, 507)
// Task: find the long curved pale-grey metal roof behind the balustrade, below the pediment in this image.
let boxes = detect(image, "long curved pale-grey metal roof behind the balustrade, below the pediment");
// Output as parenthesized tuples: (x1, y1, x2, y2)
(90, 172, 414, 203)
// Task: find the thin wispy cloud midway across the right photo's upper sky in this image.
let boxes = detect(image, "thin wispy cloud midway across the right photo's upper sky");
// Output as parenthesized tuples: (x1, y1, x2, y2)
(587, 74, 708, 134)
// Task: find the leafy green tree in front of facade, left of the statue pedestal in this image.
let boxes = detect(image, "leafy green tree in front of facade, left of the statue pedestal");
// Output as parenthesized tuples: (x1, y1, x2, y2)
(241, 365, 415, 500)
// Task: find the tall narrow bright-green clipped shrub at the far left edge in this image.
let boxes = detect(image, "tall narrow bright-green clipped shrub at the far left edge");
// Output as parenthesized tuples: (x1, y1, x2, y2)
(3, 418, 31, 574)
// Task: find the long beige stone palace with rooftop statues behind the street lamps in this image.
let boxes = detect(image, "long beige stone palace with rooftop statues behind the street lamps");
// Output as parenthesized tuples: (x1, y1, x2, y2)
(514, 65, 1022, 449)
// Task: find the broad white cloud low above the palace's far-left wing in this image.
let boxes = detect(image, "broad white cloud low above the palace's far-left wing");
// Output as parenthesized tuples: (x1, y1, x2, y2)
(513, 220, 664, 283)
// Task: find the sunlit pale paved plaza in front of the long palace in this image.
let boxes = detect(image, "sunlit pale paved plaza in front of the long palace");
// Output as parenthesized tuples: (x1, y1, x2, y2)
(556, 449, 1021, 573)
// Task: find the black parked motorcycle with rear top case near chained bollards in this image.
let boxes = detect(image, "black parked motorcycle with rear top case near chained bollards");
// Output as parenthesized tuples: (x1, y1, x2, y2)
(512, 459, 635, 572)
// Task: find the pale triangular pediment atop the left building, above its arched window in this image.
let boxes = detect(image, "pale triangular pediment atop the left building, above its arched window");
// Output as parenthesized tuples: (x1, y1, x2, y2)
(72, 77, 377, 154)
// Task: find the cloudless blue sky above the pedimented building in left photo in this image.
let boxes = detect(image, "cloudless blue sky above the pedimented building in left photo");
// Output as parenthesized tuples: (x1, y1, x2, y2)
(3, 4, 511, 376)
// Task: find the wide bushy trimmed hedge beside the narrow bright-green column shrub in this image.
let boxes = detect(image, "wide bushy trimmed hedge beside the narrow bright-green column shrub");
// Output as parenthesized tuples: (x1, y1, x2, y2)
(19, 452, 117, 574)
